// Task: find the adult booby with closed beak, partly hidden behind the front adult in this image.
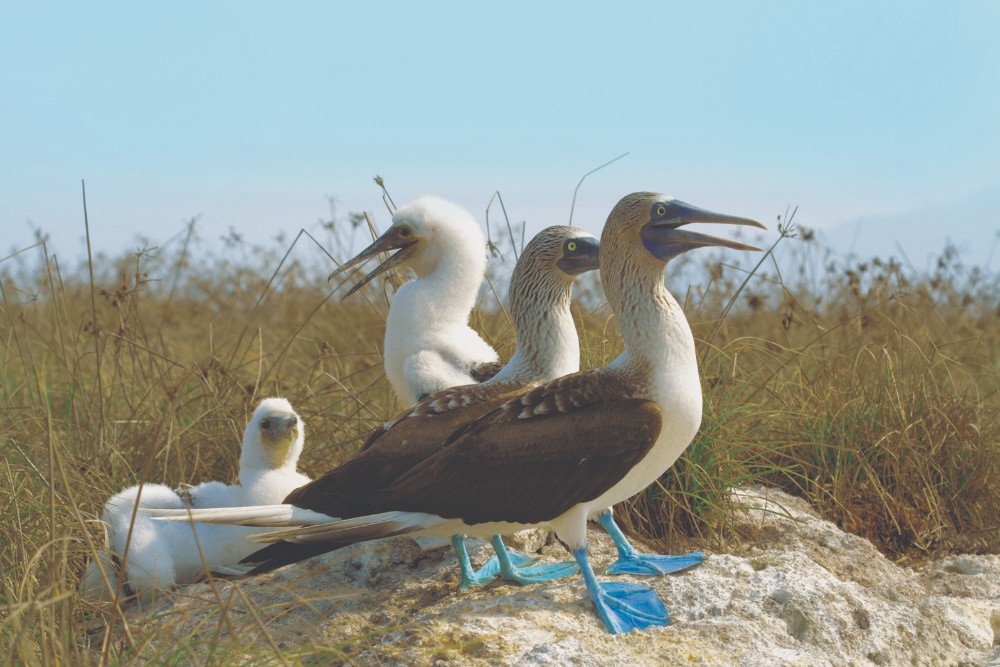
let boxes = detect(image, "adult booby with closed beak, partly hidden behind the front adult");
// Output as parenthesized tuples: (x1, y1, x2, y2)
(152, 226, 599, 588)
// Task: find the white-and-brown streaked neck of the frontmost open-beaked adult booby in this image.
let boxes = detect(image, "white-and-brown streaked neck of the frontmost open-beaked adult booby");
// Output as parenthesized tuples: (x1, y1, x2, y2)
(601, 253, 701, 396)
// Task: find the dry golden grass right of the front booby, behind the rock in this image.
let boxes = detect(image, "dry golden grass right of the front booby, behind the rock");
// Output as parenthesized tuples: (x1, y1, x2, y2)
(627, 226, 1000, 562)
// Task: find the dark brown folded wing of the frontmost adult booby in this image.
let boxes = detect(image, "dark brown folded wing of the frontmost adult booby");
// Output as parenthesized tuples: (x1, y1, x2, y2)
(380, 375, 662, 523)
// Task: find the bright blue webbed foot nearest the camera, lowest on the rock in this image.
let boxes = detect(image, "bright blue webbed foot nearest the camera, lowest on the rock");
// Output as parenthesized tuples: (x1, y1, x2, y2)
(573, 547, 670, 635)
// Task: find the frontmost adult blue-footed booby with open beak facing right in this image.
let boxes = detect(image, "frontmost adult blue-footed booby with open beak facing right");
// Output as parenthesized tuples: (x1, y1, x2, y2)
(174, 192, 762, 633)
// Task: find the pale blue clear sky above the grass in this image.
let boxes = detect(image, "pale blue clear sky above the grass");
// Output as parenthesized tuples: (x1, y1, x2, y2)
(0, 1, 1000, 267)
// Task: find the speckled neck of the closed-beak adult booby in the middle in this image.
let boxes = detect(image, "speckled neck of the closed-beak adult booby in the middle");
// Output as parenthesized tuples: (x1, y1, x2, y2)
(492, 271, 580, 384)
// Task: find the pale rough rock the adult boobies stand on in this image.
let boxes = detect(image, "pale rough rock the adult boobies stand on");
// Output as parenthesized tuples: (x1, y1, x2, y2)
(126, 487, 1000, 666)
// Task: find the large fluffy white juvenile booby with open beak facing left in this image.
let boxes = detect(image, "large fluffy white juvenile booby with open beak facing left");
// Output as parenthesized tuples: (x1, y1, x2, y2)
(330, 197, 501, 405)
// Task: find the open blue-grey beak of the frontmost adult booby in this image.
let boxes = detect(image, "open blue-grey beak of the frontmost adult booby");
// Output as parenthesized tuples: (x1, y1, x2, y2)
(639, 199, 767, 260)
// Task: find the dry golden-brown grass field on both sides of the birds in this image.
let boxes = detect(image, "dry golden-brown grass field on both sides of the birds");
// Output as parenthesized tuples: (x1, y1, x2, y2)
(0, 219, 1000, 664)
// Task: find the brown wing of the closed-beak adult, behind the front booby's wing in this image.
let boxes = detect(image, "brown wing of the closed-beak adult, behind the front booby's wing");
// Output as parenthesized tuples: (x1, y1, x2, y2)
(285, 383, 527, 519)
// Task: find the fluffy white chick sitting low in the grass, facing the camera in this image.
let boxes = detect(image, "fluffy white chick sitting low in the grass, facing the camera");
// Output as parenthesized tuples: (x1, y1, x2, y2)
(82, 398, 310, 601)
